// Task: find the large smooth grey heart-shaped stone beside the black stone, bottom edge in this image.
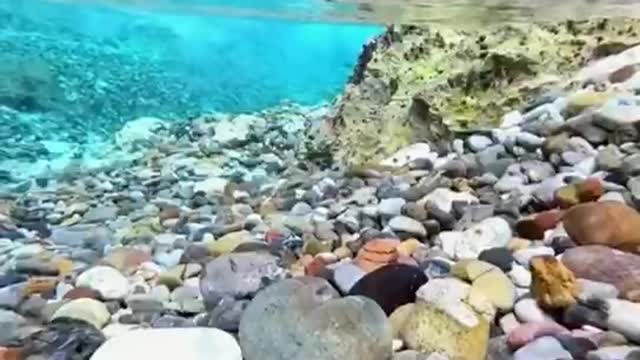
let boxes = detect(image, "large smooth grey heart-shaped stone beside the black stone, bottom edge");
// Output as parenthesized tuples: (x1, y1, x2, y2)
(239, 277, 392, 360)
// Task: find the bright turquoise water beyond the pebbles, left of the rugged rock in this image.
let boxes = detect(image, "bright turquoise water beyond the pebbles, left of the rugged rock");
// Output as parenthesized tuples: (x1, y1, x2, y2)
(0, 0, 381, 169)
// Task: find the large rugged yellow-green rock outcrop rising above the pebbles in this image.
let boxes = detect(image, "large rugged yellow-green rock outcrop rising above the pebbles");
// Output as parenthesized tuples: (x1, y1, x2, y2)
(332, 19, 639, 166)
